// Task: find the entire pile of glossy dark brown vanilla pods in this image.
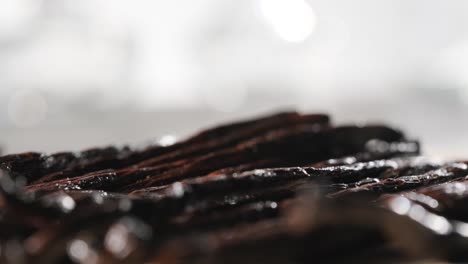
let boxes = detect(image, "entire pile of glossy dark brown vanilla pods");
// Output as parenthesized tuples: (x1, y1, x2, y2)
(0, 112, 468, 264)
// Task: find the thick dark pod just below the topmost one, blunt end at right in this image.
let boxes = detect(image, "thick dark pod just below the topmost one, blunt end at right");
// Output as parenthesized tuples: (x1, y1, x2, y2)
(125, 126, 408, 191)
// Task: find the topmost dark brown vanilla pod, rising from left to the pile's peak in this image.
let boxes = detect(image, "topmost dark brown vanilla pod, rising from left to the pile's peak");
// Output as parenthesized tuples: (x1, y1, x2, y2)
(22, 112, 329, 183)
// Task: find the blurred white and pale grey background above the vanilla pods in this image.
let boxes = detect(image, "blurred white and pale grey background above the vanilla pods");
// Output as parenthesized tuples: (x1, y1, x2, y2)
(0, 0, 468, 157)
